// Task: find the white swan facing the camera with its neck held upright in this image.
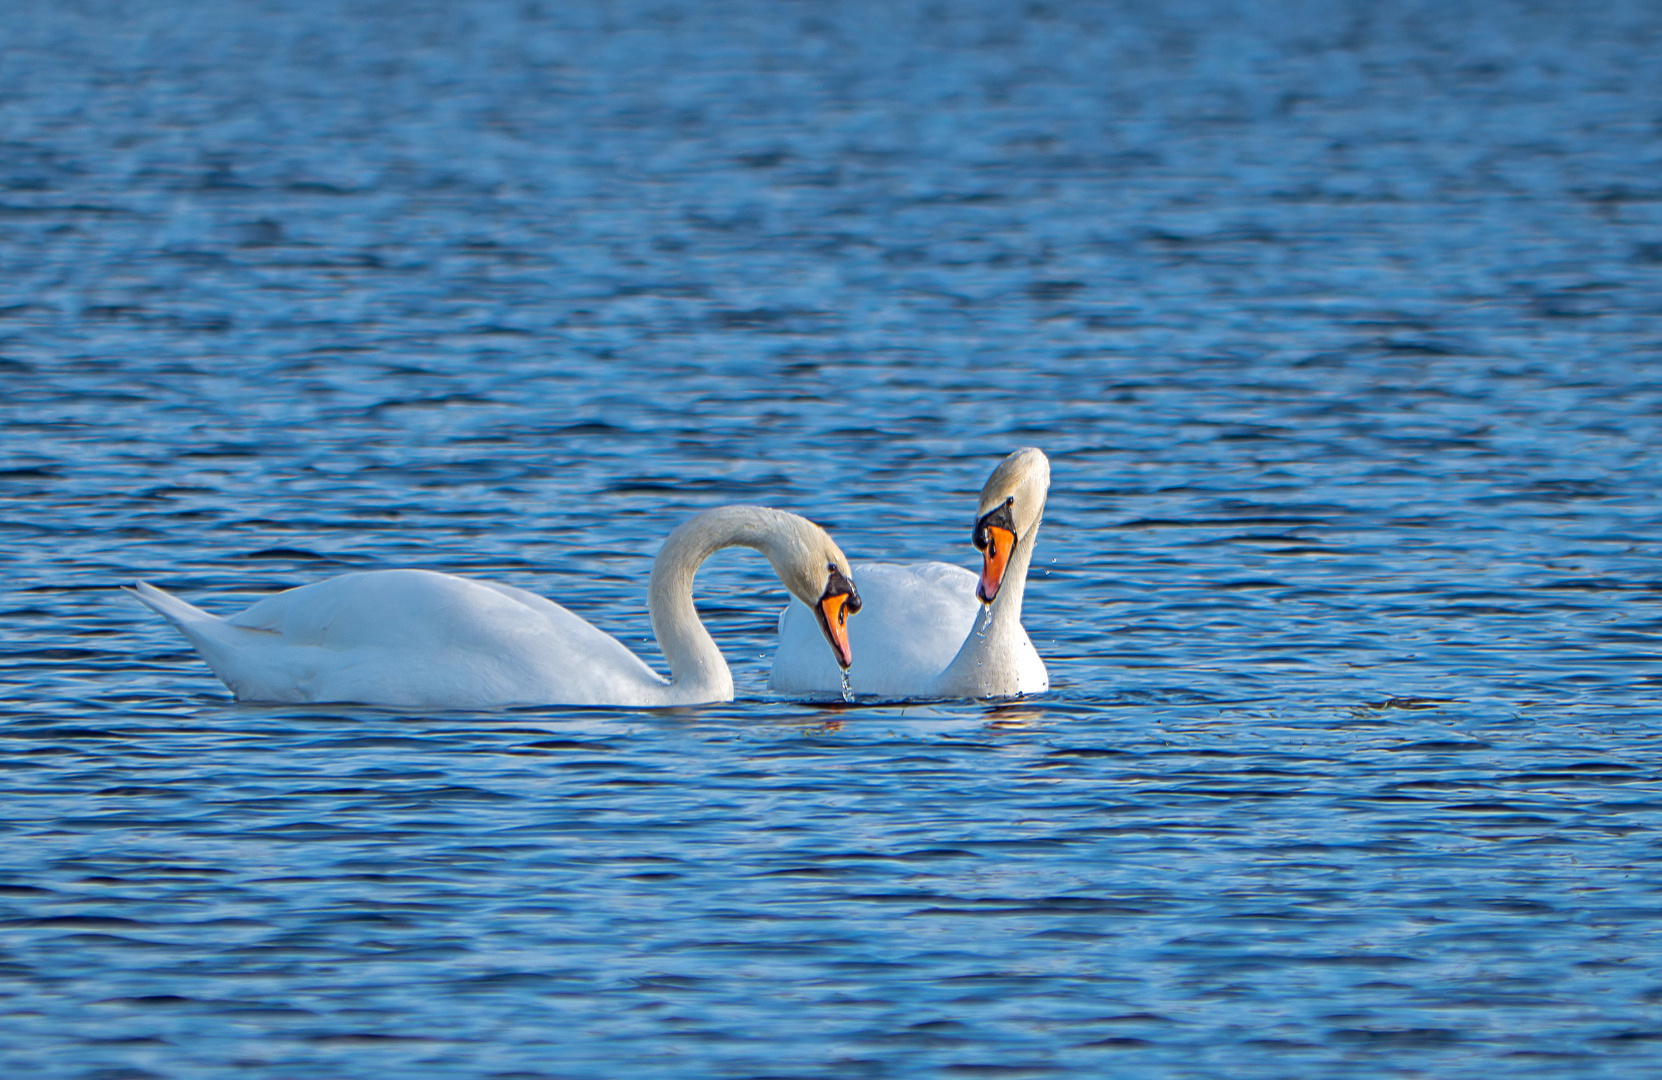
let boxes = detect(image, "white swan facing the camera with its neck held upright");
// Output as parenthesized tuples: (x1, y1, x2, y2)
(768, 447, 1050, 700)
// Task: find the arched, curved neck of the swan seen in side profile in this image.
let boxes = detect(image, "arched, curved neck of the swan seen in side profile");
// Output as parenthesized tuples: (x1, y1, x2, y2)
(647, 507, 796, 703)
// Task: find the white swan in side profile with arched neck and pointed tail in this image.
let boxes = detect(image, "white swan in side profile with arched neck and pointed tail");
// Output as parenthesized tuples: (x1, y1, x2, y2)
(123, 507, 859, 709)
